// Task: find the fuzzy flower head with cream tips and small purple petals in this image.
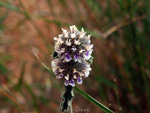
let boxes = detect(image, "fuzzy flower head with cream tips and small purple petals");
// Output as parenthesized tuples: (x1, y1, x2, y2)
(52, 25, 93, 87)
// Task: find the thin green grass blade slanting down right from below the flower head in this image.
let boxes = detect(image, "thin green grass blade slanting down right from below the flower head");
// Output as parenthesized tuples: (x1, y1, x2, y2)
(74, 87, 114, 113)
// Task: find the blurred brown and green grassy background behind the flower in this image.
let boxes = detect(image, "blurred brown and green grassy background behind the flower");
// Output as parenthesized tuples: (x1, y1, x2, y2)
(0, 0, 150, 113)
